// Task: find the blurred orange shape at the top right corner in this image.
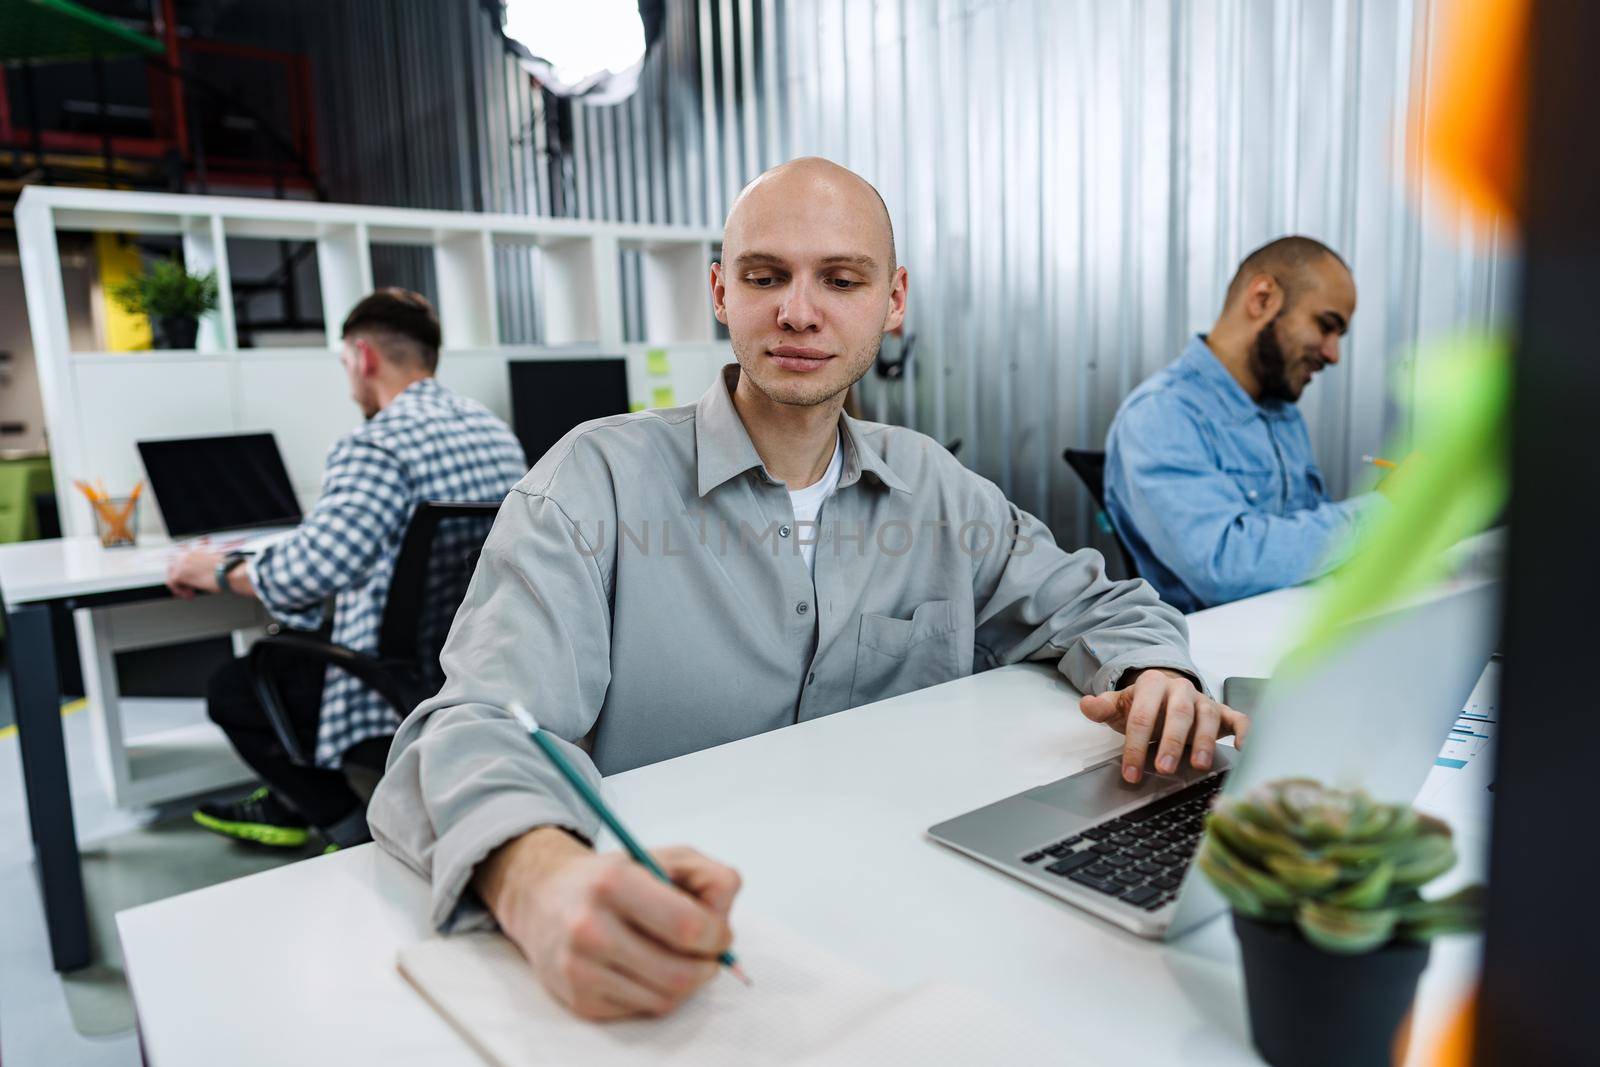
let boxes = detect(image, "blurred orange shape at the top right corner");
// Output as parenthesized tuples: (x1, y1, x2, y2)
(1411, 0, 1536, 221)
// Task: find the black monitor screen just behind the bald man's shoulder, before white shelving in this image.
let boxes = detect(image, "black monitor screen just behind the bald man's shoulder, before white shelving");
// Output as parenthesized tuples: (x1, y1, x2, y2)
(510, 358, 627, 467)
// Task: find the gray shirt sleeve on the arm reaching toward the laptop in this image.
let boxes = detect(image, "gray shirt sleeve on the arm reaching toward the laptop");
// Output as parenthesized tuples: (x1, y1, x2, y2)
(973, 480, 1202, 693)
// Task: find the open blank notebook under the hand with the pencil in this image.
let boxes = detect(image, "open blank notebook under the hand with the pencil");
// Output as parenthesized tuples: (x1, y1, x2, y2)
(400, 917, 1061, 1067)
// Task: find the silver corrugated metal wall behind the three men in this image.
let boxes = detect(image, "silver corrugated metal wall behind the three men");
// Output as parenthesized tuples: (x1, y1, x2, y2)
(297, 0, 1512, 559)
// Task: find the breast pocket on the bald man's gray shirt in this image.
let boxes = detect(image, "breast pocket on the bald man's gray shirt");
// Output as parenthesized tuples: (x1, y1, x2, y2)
(850, 600, 973, 707)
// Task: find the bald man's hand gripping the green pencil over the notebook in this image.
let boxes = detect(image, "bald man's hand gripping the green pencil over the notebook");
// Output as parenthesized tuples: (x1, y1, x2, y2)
(472, 827, 739, 1019)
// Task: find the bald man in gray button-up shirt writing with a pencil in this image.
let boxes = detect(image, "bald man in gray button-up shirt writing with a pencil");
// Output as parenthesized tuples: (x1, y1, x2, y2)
(370, 160, 1248, 1019)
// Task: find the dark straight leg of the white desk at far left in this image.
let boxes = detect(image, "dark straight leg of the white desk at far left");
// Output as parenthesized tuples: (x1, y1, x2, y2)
(8, 605, 90, 971)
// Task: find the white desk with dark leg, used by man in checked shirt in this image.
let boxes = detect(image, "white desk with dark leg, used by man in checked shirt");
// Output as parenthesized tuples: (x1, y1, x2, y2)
(0, 537, 267, 971)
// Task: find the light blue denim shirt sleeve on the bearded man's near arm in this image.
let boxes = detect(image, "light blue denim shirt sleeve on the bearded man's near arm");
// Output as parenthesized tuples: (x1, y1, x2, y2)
(1107, 395, 1387, 605)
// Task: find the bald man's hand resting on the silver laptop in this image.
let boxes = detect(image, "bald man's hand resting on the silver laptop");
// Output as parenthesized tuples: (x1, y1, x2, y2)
(1078, 667, 1250, 784)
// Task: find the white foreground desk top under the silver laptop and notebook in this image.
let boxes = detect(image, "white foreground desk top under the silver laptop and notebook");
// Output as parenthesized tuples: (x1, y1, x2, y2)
(118, 590, 1477, 1067)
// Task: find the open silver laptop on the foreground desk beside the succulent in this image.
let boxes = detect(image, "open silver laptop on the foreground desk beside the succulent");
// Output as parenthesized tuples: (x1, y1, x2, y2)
(928, 582, 1499, 939)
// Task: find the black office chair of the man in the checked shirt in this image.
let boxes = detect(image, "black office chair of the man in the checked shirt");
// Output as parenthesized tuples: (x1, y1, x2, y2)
(248, 501, 499, 773)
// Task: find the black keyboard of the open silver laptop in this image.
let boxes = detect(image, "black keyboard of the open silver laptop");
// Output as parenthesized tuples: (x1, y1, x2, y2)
(1022, 771, 1227, 912)
